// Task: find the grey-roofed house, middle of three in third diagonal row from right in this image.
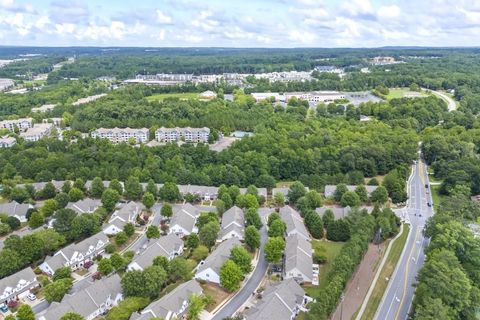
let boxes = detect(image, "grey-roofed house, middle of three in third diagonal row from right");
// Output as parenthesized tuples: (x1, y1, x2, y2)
(128, 233, 183, 270)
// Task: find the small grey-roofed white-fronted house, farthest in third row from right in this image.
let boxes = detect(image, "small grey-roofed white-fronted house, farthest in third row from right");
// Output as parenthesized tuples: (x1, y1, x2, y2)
(169, 203, 200, 237)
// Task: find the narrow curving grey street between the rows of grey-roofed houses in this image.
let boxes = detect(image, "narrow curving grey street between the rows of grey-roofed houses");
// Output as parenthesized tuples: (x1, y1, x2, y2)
(212, 226, 268, 320)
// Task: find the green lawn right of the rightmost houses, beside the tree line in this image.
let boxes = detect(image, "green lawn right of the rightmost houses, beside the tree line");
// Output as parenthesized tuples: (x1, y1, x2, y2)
(305, 240, 345, 297)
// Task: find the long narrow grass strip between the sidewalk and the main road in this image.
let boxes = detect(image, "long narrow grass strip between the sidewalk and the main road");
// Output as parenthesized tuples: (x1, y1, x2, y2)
(362, 224, 410, 320)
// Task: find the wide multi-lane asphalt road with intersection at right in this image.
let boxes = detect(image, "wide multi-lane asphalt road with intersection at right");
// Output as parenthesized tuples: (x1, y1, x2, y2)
(374, 160, 433, 320)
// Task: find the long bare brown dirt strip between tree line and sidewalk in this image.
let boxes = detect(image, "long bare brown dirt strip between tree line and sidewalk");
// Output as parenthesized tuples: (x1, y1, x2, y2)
(331, 243, 386, 320)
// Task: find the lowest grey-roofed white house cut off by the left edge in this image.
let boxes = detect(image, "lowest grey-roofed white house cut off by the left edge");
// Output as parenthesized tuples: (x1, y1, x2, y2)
(0, 267, 39, 306)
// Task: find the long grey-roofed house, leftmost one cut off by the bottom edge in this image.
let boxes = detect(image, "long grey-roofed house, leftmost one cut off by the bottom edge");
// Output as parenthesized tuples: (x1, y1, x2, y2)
(38, 274, 123, 320)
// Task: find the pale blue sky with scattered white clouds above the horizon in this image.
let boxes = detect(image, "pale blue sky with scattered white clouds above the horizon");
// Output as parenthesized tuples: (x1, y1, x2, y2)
(0, 0, 480, 48)
